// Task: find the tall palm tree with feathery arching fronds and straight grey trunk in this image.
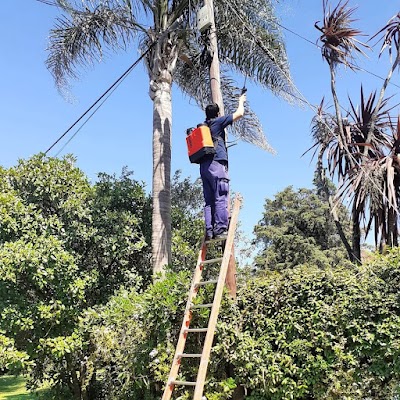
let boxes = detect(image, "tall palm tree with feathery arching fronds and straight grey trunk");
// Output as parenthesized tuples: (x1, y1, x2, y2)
(38, 0, 294, 273)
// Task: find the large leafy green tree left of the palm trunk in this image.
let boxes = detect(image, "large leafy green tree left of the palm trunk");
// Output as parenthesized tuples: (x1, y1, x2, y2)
(0, 155, 151, 399)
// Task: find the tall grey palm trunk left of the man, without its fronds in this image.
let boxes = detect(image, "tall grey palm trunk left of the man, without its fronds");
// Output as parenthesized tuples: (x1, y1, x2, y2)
(150, 79, 172, 274)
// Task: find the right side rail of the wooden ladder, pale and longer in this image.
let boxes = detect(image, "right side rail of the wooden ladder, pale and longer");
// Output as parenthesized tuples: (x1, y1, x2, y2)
(193, 196, 241, 400)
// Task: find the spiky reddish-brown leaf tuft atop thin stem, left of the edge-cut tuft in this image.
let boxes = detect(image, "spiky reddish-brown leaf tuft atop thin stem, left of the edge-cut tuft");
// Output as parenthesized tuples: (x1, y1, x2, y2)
(314, 0, 369, 69)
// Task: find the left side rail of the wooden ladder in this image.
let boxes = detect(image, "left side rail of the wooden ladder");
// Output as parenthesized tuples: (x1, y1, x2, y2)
(162, 241, 207, 400)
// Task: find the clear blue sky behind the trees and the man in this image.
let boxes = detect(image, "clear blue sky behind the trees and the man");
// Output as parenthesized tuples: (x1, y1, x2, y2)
(0, 0, 400, 244)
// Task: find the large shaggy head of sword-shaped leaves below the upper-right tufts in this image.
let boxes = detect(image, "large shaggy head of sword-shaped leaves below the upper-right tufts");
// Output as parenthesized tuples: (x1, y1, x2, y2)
(312, 88, 396, 256)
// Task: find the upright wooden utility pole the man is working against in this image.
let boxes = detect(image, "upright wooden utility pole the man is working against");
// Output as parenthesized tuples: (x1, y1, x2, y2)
(204, 0, 236, 298)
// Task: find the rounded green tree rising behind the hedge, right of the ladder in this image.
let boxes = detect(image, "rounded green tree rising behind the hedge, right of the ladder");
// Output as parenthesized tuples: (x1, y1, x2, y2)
(254, 186, 349, 270)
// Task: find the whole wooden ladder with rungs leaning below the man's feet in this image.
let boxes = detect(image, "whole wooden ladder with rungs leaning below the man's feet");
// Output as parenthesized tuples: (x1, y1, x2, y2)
(162, 196, 242, 400)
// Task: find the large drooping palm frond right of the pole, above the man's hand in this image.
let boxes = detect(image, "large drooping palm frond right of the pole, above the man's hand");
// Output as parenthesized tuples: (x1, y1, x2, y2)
(215, 0, 297, 103)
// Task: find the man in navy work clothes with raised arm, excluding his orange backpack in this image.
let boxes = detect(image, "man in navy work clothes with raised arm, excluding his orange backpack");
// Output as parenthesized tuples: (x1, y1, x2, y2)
(200, 90, 246, 240)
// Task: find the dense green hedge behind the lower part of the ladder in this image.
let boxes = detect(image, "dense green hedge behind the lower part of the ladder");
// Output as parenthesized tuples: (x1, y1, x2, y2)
(85, 250, 400, 400)
